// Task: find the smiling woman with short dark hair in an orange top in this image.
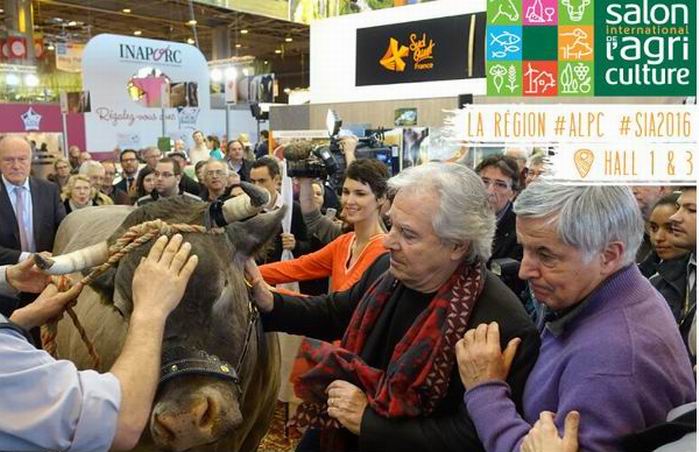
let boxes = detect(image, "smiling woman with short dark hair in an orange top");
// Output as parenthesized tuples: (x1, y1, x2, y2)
(260, 159, 388, 292)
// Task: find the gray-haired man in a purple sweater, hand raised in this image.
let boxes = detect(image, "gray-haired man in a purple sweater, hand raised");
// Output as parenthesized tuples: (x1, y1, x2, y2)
(456, 182, 695, 452)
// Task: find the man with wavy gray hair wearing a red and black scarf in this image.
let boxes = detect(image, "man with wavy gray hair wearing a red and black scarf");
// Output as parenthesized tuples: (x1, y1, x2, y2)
(247, 163, 539, 452)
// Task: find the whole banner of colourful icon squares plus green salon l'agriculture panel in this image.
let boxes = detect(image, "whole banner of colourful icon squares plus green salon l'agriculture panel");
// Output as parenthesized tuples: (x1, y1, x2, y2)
(486, 0, 697, 97)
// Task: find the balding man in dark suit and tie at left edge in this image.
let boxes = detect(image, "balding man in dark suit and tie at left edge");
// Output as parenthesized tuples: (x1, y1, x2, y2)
(0, 136, 66, 314)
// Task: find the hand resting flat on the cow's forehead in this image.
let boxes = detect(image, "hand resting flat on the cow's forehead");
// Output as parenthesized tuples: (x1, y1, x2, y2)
(132, 234, 199, 317)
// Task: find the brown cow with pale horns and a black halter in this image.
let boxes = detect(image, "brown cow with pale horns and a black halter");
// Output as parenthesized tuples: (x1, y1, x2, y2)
(37, 192, 283, 451)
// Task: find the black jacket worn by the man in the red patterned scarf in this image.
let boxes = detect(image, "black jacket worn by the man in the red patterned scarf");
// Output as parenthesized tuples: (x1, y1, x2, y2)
(262, 255, 539, 452)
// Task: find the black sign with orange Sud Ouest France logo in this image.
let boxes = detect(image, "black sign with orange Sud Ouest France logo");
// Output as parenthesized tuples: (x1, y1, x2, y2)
(355, 13, 485, 86)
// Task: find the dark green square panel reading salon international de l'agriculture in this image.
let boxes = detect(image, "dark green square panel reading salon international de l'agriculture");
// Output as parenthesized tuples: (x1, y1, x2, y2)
(594, 0, 697, 96)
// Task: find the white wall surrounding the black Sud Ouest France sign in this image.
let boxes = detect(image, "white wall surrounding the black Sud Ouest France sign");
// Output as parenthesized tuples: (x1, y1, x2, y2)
(310, 0, 486, 103)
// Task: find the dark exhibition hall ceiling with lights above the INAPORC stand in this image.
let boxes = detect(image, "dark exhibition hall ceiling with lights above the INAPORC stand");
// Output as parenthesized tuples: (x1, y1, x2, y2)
(19, 0, 309, 69)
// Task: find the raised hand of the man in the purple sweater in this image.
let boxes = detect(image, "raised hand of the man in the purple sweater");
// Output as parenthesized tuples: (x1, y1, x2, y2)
(456, 322, 521, 390)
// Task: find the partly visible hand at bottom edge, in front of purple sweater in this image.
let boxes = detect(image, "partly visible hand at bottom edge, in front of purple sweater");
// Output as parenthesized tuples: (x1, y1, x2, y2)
(520, 411, 580, 452)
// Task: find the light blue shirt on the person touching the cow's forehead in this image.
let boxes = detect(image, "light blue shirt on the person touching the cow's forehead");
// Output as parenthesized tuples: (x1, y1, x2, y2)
(0, 329, 121, 451)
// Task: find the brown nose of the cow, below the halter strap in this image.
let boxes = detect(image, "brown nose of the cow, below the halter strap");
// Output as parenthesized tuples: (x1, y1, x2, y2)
(151, 395, 242, 451)
